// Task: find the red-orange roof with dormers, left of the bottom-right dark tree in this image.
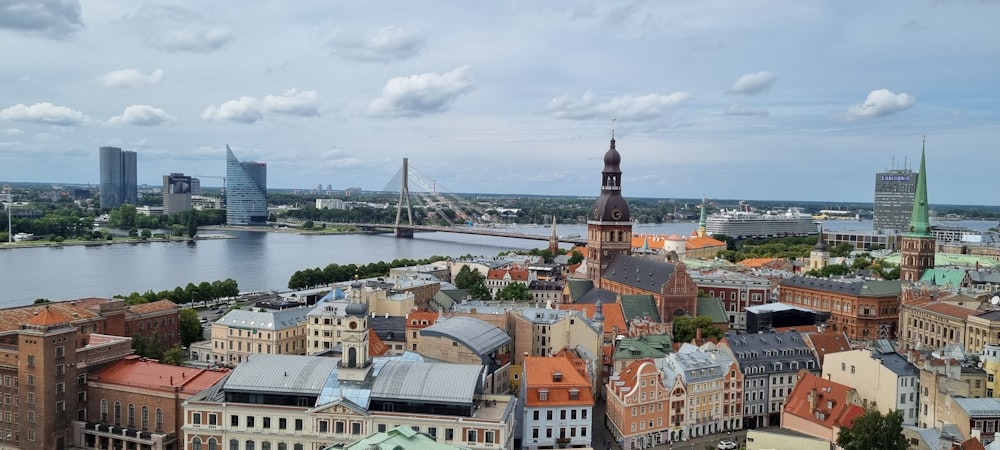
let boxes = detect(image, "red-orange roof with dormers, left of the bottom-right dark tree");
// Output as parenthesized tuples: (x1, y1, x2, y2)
(785, 369, 865, 430)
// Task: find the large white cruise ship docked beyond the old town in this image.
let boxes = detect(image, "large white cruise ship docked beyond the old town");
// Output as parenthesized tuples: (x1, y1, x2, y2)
(705, 200, 819, 238)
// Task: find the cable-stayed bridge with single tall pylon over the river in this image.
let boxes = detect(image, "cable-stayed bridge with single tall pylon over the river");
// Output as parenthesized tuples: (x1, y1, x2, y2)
(366, 158, 587, 245)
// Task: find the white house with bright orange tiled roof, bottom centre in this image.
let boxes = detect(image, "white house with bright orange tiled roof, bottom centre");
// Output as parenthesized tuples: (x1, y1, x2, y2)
(518, 352, 594, 450)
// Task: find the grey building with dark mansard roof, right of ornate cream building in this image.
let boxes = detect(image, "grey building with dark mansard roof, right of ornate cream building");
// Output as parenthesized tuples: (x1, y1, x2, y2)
(721, 331, 820, 429)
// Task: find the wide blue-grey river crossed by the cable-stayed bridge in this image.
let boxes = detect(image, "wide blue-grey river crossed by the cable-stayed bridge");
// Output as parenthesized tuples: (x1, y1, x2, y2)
(0, 220, 996, 308)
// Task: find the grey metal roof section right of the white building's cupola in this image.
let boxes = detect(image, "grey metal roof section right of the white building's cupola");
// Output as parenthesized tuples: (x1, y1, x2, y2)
(371, 361, 483, 404)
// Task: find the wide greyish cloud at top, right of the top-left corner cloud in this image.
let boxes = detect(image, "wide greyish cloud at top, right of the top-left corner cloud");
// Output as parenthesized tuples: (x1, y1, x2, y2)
(126, 4, 233, 53)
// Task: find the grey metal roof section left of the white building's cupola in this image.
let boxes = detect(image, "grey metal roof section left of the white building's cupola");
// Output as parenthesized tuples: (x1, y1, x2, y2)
(223, 354, 340, 395)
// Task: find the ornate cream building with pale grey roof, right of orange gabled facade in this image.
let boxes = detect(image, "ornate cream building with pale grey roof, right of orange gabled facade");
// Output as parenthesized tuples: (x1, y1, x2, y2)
(657, 343, 744, 441)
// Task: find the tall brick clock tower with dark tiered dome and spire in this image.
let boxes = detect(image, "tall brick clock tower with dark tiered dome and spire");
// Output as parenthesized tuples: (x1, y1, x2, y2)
(587, 129, 632, 287)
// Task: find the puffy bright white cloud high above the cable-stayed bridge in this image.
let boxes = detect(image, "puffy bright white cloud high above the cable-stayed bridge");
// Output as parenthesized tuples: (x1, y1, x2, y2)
(368, 66, 475, 117)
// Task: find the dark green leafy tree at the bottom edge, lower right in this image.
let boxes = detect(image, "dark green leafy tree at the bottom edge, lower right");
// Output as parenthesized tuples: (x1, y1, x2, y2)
(837, 403, 909, 450)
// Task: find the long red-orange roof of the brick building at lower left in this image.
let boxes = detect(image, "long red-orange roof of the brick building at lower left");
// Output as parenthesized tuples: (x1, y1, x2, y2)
(92, 355, 229, 395)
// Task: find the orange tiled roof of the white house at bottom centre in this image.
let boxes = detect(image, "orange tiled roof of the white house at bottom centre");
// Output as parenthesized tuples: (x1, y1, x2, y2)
(522, 353, 594, 407)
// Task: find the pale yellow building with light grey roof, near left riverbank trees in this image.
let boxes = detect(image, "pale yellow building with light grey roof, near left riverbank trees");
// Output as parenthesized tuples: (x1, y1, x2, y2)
(211, 305, 308, 366)
